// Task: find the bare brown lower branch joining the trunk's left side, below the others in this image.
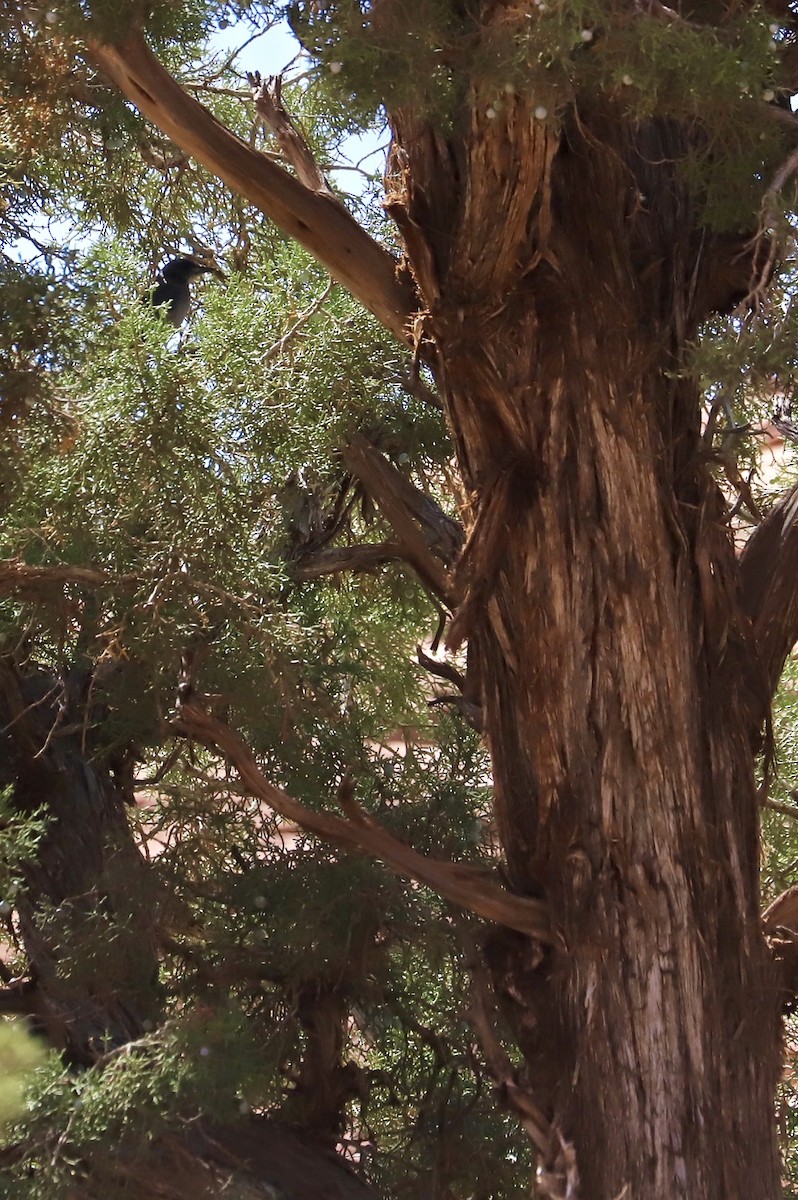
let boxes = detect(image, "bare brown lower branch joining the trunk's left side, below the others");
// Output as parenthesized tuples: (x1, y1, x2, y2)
(174, 702, 553, 942)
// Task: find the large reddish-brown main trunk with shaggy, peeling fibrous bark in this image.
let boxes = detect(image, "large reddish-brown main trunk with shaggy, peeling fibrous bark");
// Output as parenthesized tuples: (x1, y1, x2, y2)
(389, 94, 780, 1200)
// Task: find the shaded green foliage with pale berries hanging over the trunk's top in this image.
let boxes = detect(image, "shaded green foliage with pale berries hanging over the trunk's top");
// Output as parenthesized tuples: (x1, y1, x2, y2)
(289, 0, 785, 229)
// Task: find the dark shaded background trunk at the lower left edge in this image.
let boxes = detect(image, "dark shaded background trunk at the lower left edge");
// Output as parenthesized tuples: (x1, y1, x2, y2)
(0, 659, 160, 1063)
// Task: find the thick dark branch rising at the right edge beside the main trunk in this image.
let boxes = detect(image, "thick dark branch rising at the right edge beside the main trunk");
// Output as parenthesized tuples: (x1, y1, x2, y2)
(740, 487, 798, 720)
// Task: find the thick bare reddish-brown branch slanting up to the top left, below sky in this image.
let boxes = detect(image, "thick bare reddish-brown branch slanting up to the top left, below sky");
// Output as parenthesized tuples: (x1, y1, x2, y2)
(88, 32, 416, 341)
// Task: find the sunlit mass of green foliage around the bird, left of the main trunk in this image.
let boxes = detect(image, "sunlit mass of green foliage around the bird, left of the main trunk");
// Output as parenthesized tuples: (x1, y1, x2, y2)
(0, 16, 529, 1200)
